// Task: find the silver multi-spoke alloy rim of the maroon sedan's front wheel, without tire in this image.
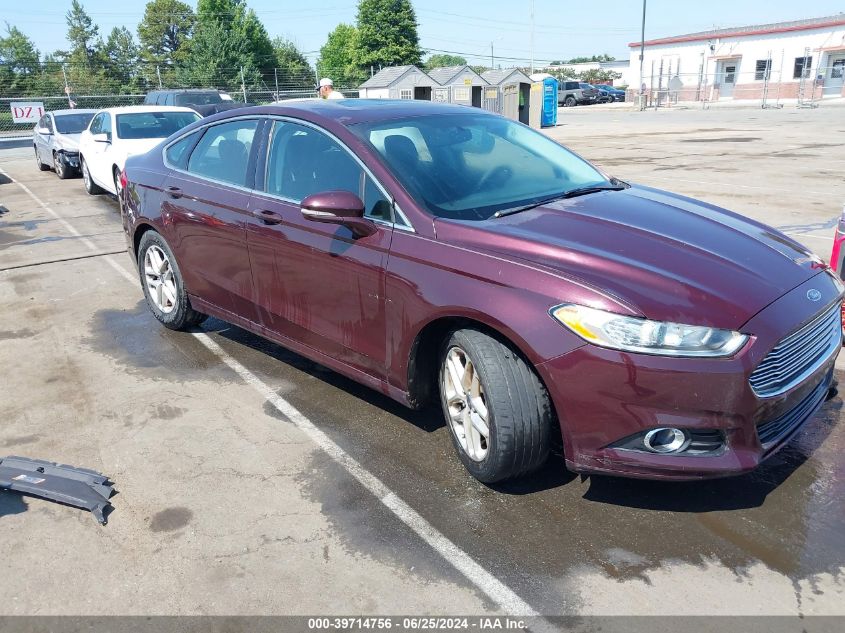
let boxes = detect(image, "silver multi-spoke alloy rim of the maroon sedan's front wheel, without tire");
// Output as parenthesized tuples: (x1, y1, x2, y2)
(442, 346, 490, 462)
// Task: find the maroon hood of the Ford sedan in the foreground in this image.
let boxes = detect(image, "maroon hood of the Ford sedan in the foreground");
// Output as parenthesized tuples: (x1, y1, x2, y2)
(435, 186, 826, 329)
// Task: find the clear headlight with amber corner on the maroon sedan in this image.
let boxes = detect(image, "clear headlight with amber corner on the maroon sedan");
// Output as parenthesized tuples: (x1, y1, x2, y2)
(551, 304, 748, 358)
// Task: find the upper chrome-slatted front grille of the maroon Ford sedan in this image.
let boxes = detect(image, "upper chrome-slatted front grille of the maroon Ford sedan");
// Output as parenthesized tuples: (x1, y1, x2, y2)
(748, 303, 842, 398)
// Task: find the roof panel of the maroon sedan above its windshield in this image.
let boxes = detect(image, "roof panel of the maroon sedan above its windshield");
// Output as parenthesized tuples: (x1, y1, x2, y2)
(215, 99, 498, 125)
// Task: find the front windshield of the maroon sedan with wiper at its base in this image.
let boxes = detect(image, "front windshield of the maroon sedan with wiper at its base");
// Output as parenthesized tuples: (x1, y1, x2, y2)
(350, 113, 609, 220)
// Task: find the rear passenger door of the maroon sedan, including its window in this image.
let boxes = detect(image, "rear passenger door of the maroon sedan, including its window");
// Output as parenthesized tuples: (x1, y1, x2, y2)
(162, 118, 262, 321)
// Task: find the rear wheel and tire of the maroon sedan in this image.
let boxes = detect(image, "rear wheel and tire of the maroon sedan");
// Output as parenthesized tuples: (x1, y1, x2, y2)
(138, 231, 206, 330)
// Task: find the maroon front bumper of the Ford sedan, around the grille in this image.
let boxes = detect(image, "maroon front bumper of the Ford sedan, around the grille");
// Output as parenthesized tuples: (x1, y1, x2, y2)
(538, 273, 840, 480)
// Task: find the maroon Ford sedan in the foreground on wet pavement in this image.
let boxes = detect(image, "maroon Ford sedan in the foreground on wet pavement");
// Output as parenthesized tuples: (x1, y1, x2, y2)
(122, 99, 843, 482)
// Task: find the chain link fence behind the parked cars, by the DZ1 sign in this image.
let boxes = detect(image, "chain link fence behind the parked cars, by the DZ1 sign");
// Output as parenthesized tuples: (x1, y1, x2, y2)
(0, 62, 358, 137)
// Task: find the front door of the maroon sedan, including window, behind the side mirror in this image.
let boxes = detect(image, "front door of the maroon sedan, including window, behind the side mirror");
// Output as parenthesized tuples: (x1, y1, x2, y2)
(247, 119, 393, 379)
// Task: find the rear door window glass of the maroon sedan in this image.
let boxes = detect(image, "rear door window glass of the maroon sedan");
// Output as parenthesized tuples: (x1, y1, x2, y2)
(187, 119, 258, 187)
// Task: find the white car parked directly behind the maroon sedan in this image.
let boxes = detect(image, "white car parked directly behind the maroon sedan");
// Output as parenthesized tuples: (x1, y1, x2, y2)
(79, 106, 201, 195)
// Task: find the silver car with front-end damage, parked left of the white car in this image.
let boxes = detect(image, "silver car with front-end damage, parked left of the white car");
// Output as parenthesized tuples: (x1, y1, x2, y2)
(32, 110, 96, 179)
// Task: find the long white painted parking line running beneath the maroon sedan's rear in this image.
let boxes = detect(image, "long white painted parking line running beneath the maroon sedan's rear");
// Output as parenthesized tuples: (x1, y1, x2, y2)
(0, 168, 545, 628)
